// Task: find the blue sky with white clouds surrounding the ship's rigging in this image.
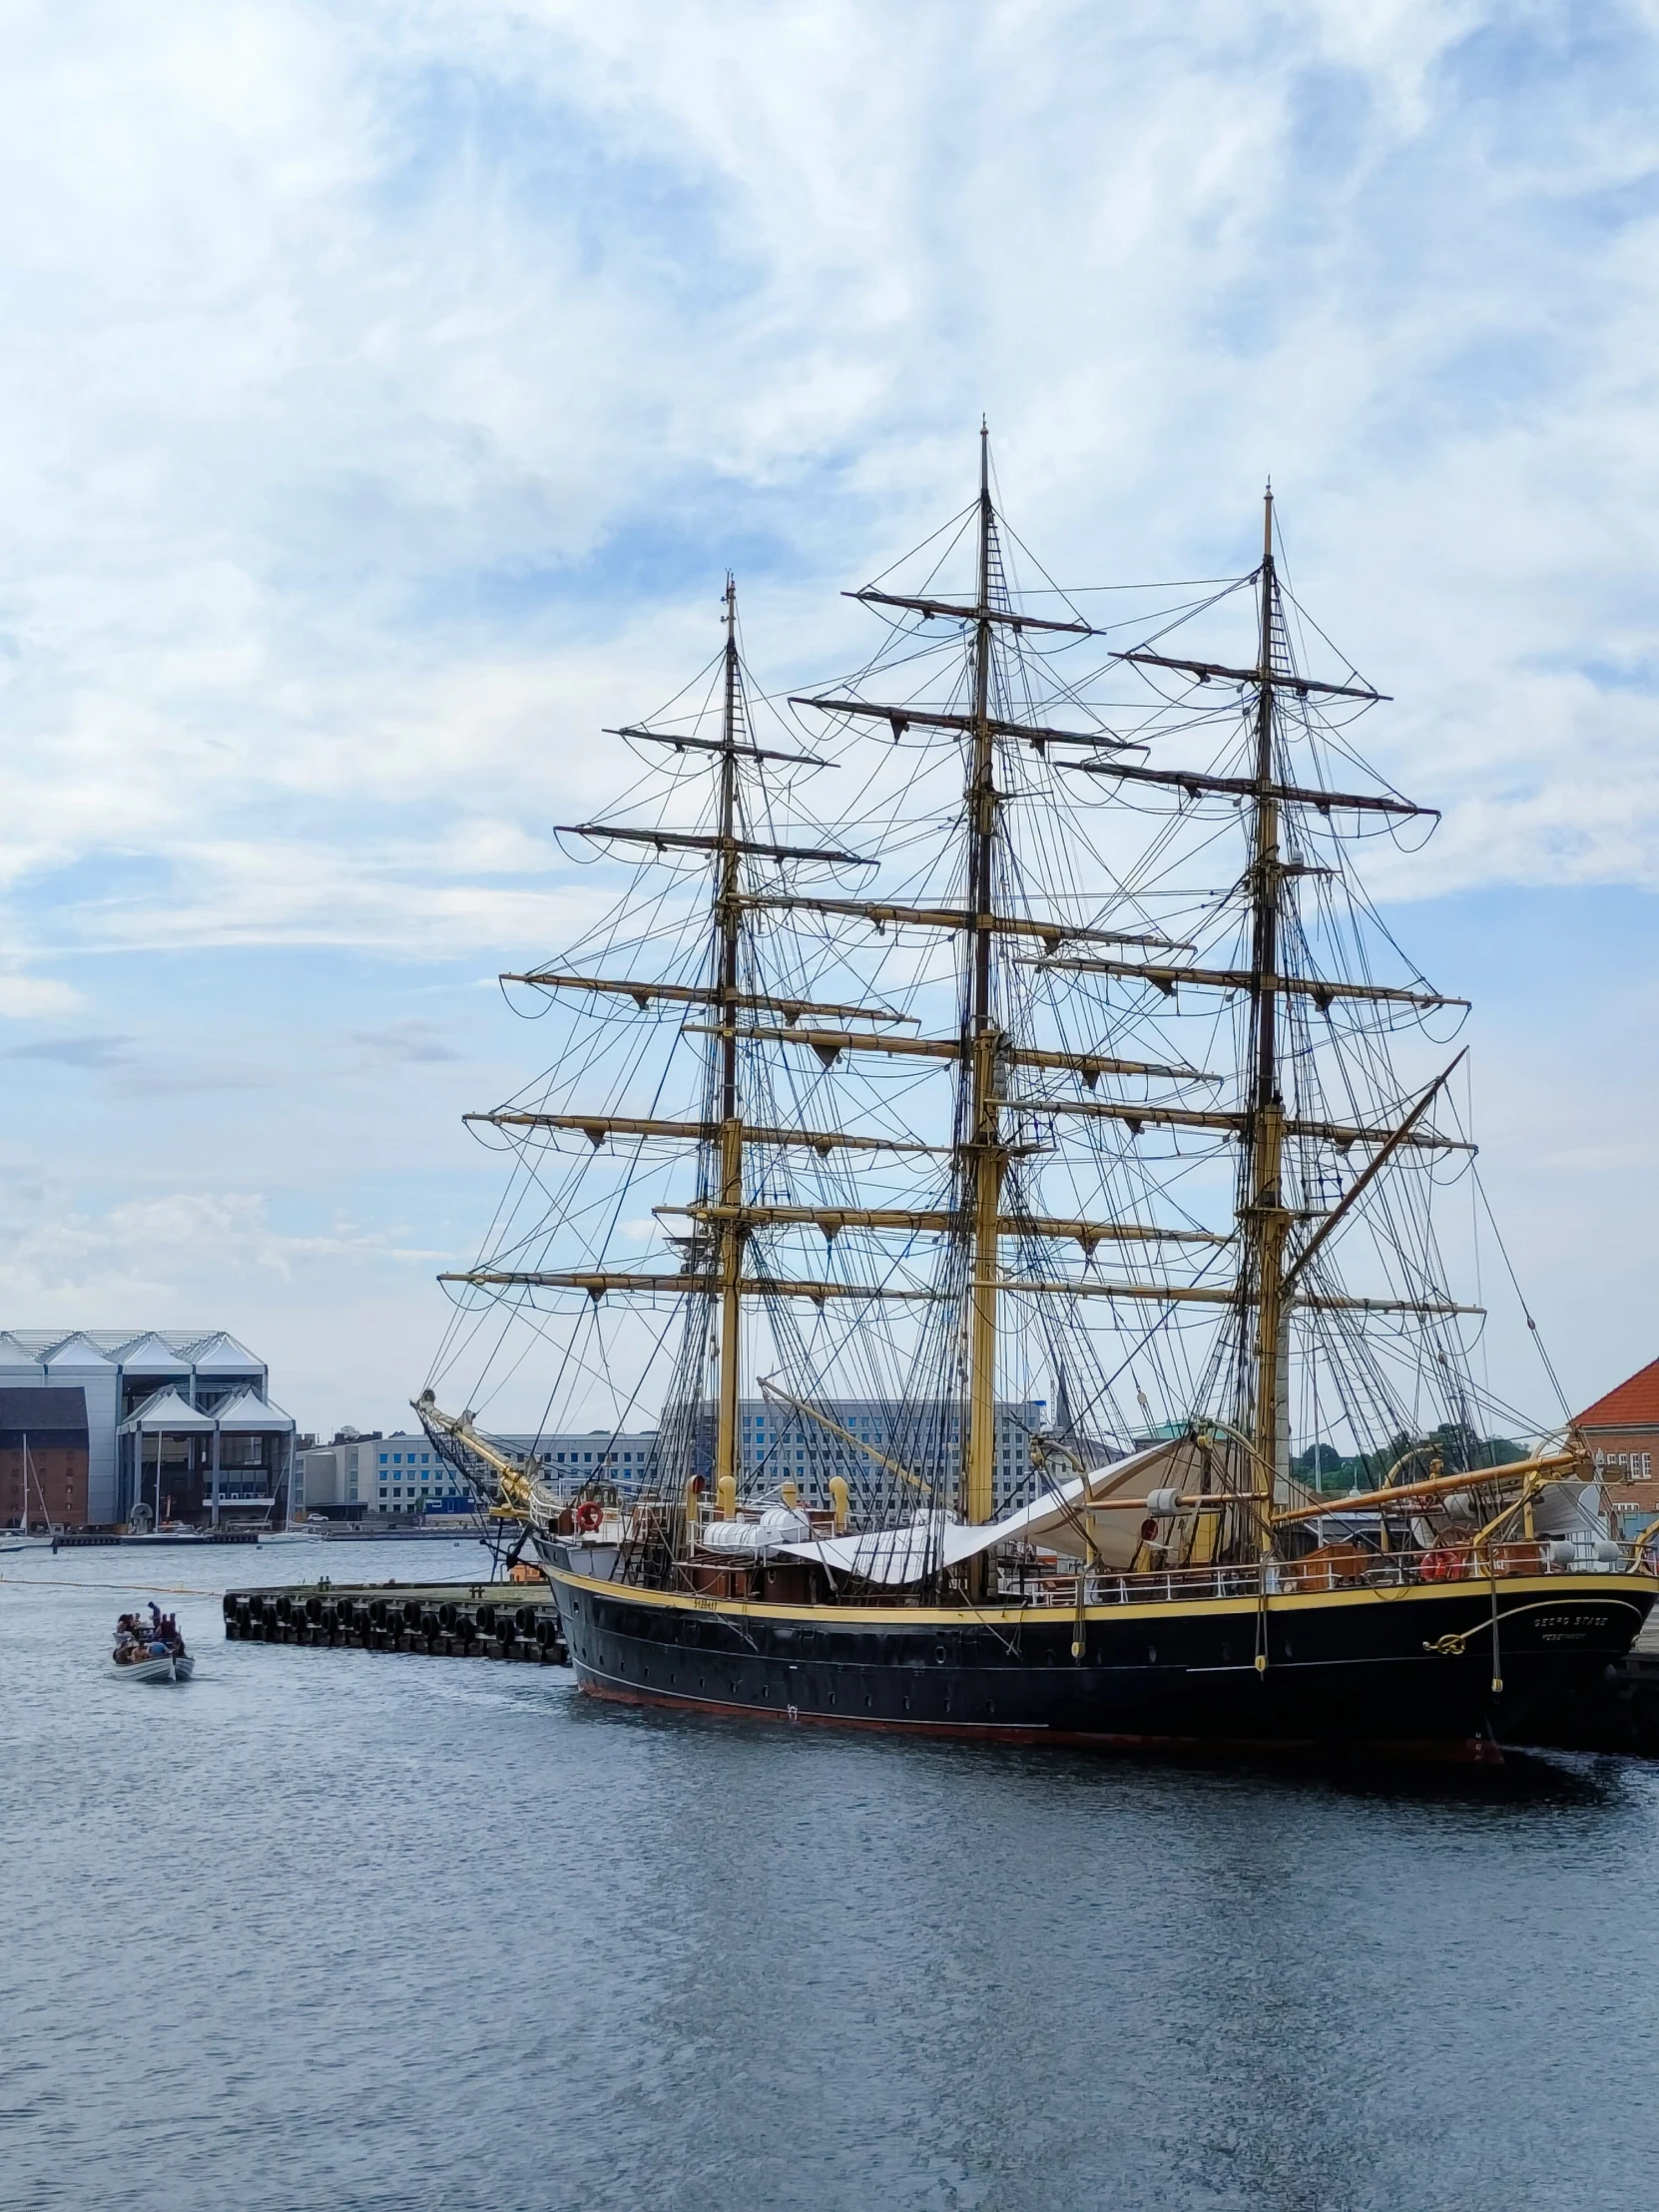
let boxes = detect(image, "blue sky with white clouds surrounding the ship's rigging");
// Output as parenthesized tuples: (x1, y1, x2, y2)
(0, 0, 1659, 1426)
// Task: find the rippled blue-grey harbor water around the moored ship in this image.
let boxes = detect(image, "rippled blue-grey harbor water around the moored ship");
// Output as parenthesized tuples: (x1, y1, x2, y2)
(0, 1542, 1659, 2212)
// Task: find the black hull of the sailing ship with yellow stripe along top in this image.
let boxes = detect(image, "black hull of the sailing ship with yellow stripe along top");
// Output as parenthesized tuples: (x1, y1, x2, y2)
(542, 1539, 1659, 1759)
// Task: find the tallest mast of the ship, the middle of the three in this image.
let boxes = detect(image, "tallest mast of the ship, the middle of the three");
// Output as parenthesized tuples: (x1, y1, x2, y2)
(962, 422, 1008, 1522)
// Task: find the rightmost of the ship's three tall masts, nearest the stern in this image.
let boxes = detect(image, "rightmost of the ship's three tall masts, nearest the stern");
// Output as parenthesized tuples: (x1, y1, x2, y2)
(1239, 484, 1290, 1495)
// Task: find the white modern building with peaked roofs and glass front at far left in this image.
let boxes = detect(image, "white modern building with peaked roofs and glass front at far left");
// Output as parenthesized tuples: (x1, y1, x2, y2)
(0, 1330, 294, 1528)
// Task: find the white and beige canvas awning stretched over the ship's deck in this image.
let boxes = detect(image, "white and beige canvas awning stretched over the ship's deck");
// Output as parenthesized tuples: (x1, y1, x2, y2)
(779, 1435, 1197, 1586)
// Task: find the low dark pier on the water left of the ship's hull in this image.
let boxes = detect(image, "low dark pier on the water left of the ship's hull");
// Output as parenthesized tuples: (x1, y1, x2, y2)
(226, 1581, 571, 1666)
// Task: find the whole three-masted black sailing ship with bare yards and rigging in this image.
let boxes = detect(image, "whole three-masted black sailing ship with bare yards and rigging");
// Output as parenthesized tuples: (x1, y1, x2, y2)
(418, 433, 1659, 1757)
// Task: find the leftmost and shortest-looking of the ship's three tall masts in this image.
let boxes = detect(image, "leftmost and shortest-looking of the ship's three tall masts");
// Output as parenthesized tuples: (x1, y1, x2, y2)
(715, 575, 746, 1499)
